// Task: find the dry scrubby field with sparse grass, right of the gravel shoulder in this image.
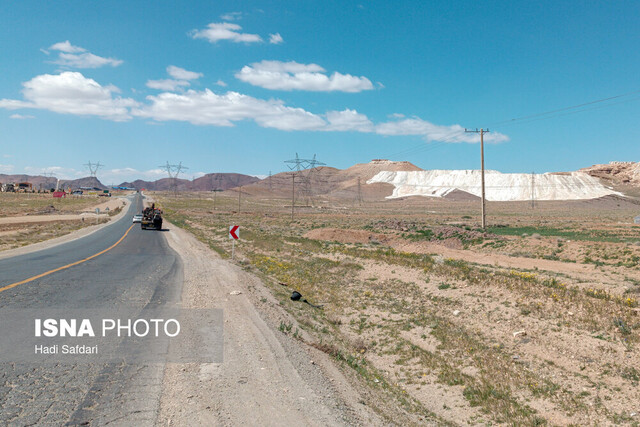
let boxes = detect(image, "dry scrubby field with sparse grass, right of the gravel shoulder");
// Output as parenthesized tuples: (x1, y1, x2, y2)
(154, 193, 640, 425)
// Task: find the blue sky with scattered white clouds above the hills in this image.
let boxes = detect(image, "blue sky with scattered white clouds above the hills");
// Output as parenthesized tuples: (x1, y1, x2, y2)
(0, 0, 640, 183)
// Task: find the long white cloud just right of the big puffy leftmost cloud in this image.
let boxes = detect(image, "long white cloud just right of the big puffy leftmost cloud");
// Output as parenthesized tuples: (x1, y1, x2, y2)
(132, 89, 326, 130)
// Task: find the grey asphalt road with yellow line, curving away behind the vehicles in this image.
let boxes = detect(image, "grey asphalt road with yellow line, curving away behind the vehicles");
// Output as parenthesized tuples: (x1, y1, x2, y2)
(0, 195, 183, 426)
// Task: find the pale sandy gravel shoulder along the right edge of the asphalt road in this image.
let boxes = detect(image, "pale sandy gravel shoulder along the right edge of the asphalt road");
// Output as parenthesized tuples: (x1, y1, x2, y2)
(158, 226, 382, 426)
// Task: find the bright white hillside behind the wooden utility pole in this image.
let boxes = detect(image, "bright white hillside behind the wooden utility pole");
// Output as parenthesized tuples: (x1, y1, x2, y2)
(367, 170, 621, 201)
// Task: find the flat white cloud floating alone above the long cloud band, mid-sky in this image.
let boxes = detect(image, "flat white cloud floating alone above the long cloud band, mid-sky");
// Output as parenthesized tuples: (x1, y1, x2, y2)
(235, 61, 373, 93)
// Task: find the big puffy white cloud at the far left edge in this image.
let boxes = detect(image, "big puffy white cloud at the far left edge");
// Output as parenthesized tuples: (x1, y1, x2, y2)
(0, 71, 138, 121)
